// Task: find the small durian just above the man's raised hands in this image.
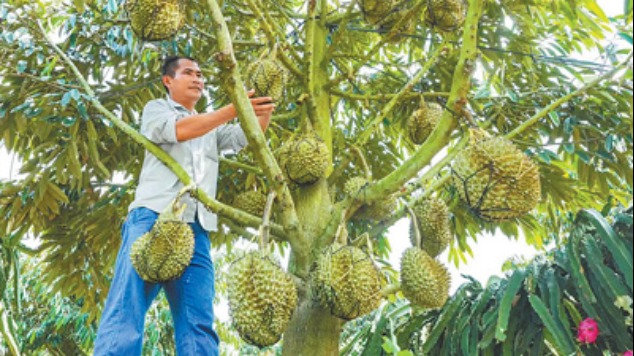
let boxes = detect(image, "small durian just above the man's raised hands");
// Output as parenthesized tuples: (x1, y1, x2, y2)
(246, 51, 288, 101)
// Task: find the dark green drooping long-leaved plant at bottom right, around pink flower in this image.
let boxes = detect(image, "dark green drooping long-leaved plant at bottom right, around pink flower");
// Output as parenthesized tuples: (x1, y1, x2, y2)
(345, 208, 633, 355)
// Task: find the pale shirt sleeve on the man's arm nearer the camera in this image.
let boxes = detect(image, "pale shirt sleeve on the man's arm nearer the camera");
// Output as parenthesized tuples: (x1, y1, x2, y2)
(141, 99, 180, 144)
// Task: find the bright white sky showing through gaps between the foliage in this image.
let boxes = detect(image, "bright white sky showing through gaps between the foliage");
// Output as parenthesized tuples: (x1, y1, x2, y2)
(0, 0, 623, 321)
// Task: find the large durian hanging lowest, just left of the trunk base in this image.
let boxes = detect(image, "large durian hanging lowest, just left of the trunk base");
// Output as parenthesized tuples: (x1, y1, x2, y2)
(227, 251, 297, 347)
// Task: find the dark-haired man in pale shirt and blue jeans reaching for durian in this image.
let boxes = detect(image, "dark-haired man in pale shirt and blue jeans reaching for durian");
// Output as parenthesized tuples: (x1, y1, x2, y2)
(94, 57, 275, 356)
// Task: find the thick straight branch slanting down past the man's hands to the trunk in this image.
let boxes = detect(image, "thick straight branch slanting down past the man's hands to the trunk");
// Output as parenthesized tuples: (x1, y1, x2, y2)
(207, 0, 309, 275)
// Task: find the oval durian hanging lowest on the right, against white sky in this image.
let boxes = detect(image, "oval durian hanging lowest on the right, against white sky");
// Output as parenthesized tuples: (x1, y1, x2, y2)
(401, 247, 451, 308)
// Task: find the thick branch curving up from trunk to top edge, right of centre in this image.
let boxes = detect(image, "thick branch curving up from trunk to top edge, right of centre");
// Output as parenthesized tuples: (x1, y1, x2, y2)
(364, 0, 484, 206)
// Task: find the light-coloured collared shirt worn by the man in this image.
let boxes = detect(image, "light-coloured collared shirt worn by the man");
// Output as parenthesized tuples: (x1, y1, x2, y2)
(129, 97, 247, 231)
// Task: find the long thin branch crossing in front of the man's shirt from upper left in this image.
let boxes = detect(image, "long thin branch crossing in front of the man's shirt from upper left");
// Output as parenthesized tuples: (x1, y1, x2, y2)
(38, 22, 284, 236)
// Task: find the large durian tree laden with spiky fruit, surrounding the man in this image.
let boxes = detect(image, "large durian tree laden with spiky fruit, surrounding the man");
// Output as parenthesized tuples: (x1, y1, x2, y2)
(0, 0, 632, 355)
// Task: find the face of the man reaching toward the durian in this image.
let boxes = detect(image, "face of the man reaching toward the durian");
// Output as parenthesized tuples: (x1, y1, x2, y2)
(163, 58, 204, 103)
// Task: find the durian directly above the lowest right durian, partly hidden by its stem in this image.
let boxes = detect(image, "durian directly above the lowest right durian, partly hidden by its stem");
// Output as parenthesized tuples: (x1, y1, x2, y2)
(410, 198, 453, 258)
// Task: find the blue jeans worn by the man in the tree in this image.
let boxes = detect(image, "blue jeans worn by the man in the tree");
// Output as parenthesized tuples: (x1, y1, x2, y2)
(94, 208, 219, 356)
